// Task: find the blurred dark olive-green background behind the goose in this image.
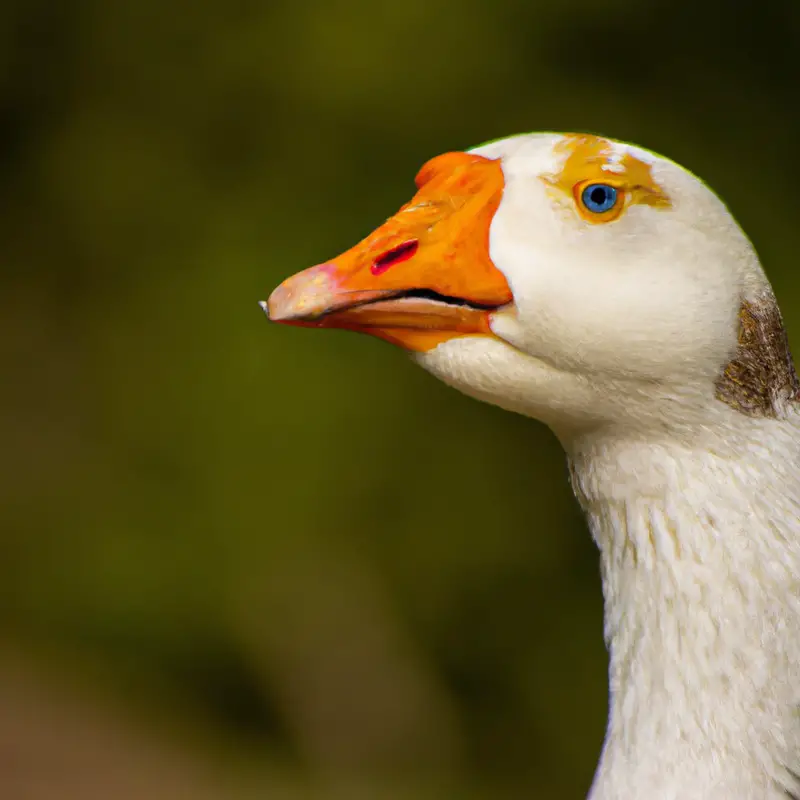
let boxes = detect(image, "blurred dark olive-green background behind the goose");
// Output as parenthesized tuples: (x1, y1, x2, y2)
(0, 0, 800, 800)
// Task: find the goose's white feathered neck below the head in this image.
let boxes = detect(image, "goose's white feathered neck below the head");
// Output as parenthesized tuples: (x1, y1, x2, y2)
(570, 422, 800, 800)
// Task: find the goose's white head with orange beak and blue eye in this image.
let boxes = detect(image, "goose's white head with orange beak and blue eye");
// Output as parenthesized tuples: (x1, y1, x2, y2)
(262, 133, 788, 440)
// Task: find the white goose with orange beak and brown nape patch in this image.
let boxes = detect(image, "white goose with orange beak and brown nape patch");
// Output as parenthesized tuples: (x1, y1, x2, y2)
(261, 133, 800, 800)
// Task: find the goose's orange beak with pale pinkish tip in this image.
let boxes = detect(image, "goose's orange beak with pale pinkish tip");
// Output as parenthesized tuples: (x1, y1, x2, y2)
(261, 153, 513, 351)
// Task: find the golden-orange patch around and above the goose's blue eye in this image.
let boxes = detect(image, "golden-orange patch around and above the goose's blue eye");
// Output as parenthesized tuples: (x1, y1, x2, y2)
(542, 134, 672, 224)
